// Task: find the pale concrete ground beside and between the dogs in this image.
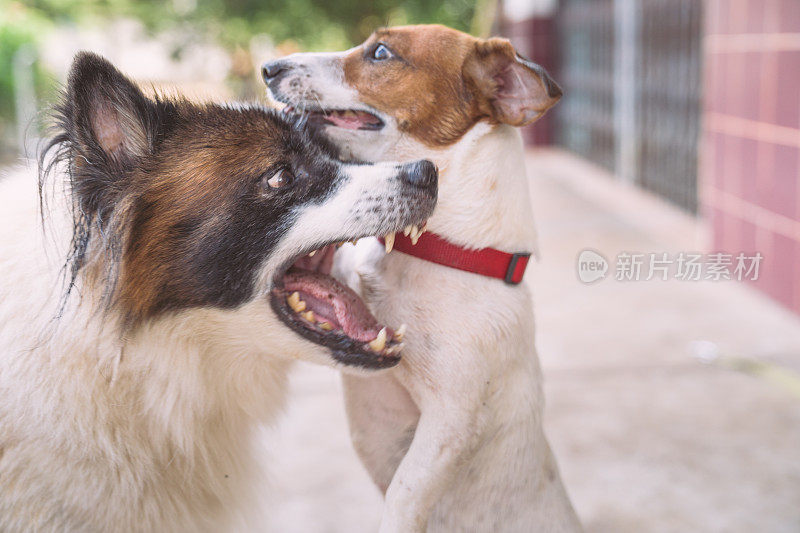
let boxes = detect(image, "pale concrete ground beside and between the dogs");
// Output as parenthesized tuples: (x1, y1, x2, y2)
(264, 151, 800, 533)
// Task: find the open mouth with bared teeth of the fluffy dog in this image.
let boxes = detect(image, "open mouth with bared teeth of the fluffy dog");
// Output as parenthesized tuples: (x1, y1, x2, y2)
(270, 224, 425, 369)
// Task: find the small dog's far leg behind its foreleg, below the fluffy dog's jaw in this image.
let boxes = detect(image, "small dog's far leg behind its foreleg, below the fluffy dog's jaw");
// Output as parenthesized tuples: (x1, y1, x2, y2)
(342, 371, 419, 494)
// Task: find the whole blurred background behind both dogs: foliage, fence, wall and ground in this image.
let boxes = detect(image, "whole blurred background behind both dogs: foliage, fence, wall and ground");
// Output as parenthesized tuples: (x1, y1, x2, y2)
(0, 0, 800, 533)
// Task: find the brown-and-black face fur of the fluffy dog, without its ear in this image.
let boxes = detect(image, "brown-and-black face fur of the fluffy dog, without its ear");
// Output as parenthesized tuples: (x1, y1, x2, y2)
(118, 102, 336, 323)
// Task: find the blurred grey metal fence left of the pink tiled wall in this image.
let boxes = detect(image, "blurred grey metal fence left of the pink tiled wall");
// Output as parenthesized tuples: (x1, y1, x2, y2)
(556, 0, 702, 212)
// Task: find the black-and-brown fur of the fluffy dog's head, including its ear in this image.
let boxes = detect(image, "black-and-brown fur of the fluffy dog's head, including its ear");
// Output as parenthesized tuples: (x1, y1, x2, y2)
(39, 53, 350, 326)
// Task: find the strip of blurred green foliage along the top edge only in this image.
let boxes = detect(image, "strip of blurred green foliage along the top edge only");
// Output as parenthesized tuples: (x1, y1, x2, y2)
(14, 0, 475, 50)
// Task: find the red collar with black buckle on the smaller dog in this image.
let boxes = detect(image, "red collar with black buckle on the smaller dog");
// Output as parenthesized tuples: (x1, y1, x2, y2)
(380, 231, 531, 285)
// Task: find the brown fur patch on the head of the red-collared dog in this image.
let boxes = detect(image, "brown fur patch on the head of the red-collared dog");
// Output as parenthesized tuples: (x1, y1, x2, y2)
(343, 25, 560, 147)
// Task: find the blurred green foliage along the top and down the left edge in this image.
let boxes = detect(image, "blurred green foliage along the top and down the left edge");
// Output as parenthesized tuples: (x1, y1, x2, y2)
(0, 0, 476, 150)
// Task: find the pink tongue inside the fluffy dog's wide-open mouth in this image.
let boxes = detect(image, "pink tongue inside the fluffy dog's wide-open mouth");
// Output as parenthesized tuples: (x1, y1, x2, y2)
(283, 269, 381, 342)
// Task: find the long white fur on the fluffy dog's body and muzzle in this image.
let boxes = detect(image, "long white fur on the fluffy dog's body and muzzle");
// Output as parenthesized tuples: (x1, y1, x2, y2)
(0, 156, 418, 533)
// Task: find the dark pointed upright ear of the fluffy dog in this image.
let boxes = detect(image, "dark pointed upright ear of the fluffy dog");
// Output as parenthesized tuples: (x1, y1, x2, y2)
(66, 52, 156, 171)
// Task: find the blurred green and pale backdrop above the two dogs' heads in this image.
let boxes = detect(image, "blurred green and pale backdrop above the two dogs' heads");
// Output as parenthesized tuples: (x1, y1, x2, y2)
(0, 0, 482, 157)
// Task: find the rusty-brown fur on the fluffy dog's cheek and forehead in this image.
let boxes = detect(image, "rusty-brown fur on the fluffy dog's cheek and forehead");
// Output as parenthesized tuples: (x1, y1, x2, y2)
(119, 105, 283, 321)
